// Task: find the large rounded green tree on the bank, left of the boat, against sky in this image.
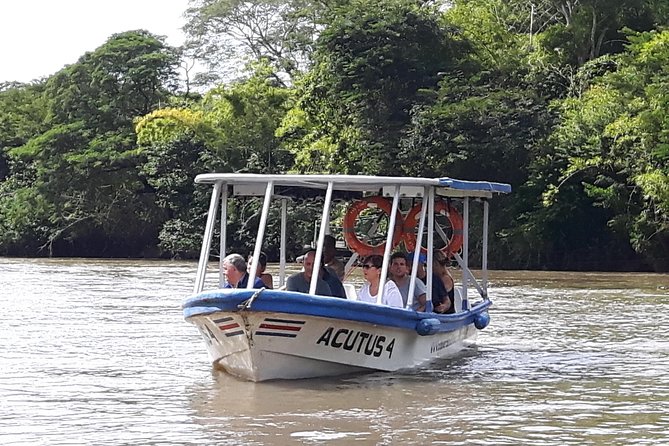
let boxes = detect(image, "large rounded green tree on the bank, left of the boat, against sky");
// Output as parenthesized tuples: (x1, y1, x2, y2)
(0, 31, 178, 256)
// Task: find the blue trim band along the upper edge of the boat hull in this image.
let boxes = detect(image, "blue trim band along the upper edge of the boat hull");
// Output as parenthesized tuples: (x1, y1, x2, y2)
(183, 289, 492, 335)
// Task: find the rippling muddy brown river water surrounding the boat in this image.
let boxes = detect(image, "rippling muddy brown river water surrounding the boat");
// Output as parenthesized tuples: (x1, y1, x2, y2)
(0, 259, 669, 445)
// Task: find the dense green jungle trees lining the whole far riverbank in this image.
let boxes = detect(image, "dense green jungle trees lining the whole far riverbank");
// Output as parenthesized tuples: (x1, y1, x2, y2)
(0, 0, 669, 271)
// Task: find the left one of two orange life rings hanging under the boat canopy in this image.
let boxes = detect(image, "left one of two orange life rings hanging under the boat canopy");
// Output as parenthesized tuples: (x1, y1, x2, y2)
(343, 196, 404, 256)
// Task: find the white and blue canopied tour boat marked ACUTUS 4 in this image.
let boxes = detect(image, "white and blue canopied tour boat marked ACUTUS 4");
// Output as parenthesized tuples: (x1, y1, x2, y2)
(182, 173, 511, 381)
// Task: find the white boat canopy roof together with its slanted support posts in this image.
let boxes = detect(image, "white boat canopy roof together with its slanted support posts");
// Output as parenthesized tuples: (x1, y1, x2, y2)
(194, 174, 510, 308)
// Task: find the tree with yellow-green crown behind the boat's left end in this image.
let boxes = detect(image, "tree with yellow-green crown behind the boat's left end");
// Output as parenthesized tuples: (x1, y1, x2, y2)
(136, 64, 292, 257)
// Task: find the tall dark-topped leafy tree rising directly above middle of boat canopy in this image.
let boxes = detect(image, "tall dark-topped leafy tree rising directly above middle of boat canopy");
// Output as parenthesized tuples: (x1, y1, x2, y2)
(281, 0, 465, 174)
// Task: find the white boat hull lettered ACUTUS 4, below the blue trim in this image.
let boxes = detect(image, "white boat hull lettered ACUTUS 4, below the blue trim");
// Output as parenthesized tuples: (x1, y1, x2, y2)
(189, 311, 477, 381)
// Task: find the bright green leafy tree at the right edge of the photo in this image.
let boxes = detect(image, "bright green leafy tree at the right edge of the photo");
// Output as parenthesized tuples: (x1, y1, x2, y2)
(544, 31, 669, 271)
